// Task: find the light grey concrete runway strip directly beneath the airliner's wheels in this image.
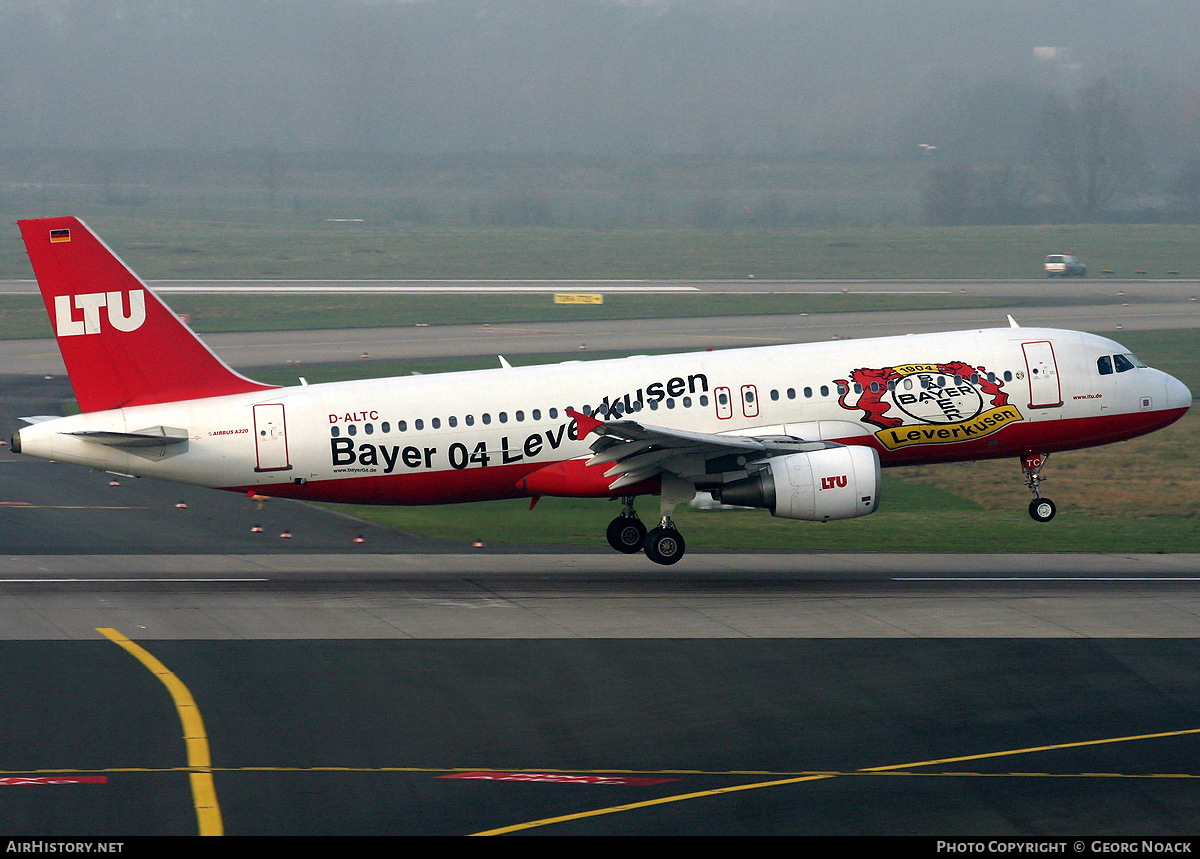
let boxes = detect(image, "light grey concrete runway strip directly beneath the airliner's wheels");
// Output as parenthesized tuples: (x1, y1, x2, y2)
(7, 554, 1200, 641)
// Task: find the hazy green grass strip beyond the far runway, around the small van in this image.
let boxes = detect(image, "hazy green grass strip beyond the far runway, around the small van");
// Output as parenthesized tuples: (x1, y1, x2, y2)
(7, 216, 1200, 280)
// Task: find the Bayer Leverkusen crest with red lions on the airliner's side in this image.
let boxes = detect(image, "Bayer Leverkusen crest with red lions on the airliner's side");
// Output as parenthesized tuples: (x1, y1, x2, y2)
(835, 361, 1021, 450)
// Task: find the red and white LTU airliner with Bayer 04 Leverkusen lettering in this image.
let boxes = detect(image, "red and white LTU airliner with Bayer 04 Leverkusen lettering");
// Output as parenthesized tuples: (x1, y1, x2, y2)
(12, 217, 1192, 564)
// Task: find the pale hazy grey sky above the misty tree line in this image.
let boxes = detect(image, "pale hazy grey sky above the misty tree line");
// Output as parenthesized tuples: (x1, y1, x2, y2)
(0, 0, 1200, 158)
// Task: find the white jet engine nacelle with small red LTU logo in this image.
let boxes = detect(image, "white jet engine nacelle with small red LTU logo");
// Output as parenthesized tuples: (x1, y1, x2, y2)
(713, 445, 880, 522)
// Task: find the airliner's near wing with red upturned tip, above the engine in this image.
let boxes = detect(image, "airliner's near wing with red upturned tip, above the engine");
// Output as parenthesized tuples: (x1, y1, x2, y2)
(568, 409, 842, 489)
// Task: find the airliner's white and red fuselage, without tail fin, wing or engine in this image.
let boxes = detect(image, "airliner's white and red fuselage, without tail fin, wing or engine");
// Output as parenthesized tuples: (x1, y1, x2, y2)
(18, 328, 1190, 504)
